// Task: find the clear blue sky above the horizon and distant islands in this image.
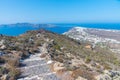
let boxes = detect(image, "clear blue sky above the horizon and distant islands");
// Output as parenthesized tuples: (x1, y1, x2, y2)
(0, 0, 120, 24)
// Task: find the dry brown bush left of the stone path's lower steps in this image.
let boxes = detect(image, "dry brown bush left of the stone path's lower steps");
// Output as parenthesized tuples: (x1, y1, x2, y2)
(2, 55, 21, 80)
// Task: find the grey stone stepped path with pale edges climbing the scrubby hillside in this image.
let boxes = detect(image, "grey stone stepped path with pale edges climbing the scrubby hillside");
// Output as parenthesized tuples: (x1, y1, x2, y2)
(18, 45, 60, 80)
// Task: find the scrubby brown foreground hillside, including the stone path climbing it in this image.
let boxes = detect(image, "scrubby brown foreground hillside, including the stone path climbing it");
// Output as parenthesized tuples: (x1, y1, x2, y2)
(0, 29, 120, 80)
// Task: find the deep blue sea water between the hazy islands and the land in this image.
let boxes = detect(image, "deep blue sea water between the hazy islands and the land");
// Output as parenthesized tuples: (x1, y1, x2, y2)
(0, 23, 120, 36)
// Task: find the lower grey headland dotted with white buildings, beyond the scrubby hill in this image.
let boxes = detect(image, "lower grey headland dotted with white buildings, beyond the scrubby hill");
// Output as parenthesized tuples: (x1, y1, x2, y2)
(64, 27, 120, 53)
